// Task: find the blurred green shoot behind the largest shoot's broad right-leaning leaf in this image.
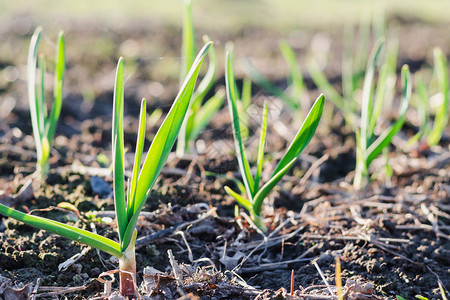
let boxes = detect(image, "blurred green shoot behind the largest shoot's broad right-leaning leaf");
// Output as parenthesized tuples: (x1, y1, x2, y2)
(177, 0, 224, 157)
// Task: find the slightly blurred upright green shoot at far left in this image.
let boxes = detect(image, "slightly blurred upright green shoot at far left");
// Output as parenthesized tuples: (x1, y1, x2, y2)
(27, 27, 65, 177)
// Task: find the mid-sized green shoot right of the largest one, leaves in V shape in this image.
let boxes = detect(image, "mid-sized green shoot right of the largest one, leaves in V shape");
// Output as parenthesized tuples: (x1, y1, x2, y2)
(225, 50, 325, 230)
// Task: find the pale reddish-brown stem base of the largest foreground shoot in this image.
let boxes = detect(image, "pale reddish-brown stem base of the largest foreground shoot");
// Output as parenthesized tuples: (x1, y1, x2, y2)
(119, 231, 137, 299)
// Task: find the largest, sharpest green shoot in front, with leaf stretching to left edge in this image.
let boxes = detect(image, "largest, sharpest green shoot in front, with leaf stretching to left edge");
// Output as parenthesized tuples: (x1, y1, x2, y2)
(0, 43, 211, 298)
